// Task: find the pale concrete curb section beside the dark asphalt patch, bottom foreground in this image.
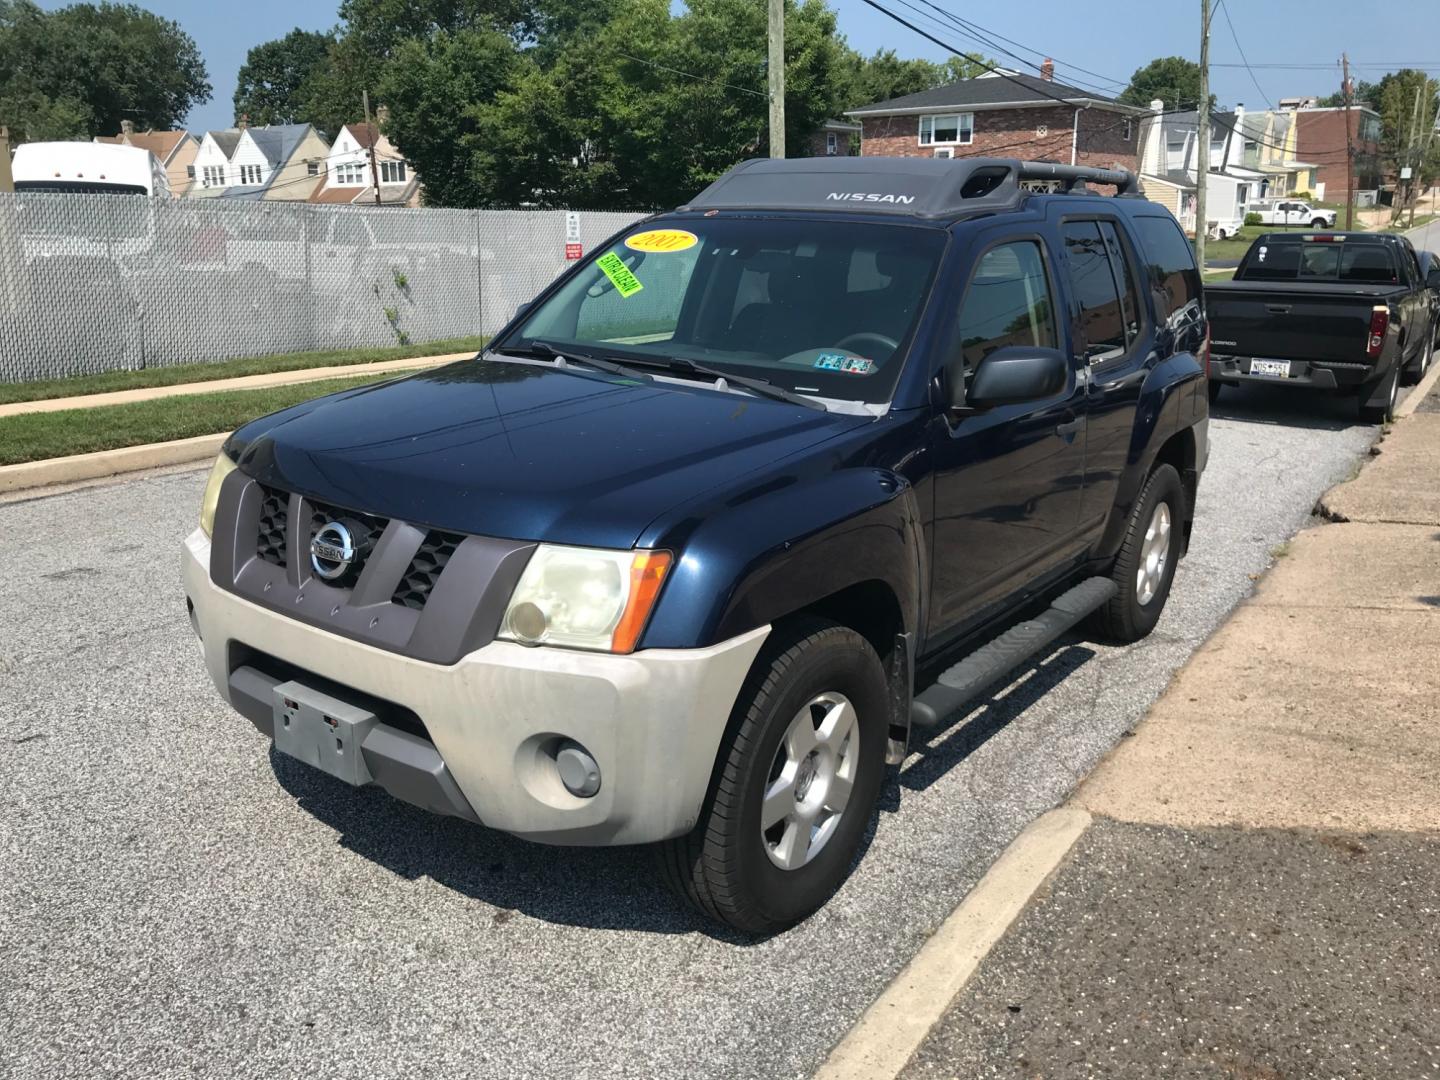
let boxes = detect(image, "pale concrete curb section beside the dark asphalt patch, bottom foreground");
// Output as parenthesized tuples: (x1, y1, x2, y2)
(814, 806, 1090, 1080)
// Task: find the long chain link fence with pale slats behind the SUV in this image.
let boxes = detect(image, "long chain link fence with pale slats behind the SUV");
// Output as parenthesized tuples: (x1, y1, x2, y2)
(0, 193, 641, 382)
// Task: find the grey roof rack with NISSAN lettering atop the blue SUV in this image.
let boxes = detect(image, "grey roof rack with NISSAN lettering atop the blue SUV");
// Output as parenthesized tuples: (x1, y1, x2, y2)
(680, 157, 1140, 219)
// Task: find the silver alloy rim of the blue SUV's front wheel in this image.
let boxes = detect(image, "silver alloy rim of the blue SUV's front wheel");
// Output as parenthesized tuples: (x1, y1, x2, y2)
(760, 690, 860, 870)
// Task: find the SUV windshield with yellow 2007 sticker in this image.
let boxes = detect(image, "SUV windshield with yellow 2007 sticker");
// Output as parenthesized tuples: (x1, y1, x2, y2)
(500, 217, 945, 403)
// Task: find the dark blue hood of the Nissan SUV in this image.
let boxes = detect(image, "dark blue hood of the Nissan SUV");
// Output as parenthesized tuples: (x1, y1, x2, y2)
(229, 357, 870, 549)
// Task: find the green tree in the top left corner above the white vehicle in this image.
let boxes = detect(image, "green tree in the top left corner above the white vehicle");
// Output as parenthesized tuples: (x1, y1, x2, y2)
(0, 0, 210, 141)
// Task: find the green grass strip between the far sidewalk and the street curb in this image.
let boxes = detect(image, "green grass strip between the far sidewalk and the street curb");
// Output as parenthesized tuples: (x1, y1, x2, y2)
(0, 372, 411, 465)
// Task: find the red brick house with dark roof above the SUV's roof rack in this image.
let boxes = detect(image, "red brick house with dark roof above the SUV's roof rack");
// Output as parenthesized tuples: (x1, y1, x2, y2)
(845, 60, 1149, 173)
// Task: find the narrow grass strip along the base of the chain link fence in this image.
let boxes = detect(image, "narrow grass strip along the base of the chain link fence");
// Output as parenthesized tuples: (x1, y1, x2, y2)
(0, 337, 487, 405)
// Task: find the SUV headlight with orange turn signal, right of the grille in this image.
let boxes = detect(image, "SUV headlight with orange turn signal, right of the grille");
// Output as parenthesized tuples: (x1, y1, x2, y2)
(500, 544, 670, 652)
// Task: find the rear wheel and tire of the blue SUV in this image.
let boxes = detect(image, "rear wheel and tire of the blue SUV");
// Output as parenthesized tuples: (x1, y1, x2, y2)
(1090, 465, 1187, 645)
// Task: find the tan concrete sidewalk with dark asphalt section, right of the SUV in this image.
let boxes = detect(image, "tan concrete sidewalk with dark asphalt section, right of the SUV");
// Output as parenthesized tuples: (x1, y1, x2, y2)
(903, 385, 1440, 1080)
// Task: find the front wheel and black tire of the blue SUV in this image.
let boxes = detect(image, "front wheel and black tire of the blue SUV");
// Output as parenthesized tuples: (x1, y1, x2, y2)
(658, 618, 890, 935)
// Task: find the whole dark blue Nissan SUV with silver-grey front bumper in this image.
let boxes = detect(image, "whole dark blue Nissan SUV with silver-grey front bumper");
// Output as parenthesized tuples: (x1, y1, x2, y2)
(183, 157, 1210, 932)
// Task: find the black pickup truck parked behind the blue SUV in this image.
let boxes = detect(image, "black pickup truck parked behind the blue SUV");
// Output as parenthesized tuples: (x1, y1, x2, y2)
(1205, 232, 1440, 423)
